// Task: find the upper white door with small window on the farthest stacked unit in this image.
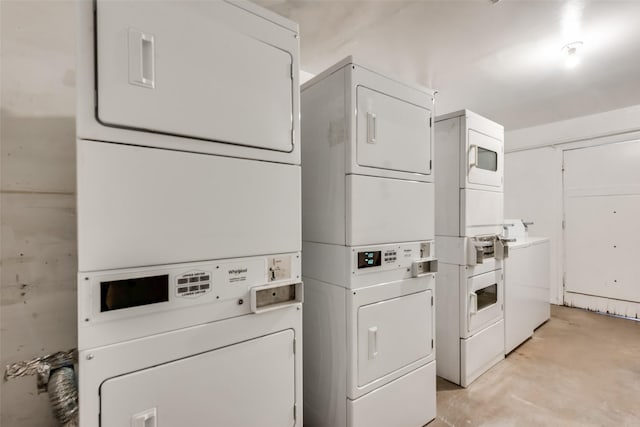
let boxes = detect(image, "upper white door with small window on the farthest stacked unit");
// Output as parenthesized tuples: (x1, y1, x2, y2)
(467, 129, 504, 189)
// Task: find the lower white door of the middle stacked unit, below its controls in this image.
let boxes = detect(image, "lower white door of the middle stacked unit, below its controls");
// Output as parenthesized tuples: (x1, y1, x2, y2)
(358, 290, 434, 387)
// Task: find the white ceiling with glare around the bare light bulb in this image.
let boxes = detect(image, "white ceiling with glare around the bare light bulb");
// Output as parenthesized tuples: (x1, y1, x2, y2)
(258, 0, 640, 129)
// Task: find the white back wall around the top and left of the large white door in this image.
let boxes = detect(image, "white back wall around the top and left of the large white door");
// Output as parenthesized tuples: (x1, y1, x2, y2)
(505, 105, 640, 307)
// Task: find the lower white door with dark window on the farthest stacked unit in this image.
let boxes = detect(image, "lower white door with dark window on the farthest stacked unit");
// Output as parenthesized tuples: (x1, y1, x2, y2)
(464, 270, 504, 337)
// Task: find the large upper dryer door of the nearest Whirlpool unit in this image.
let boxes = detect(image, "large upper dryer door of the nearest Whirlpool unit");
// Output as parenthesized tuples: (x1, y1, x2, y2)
(96, 0, 298, 152)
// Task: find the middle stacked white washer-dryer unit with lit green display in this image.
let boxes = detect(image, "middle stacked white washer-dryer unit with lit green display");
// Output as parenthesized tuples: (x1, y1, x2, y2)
(301, 57, 437, 427)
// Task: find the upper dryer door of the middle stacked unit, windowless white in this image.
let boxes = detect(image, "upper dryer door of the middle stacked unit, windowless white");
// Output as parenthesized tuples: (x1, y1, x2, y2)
(356, 86, 431, 175)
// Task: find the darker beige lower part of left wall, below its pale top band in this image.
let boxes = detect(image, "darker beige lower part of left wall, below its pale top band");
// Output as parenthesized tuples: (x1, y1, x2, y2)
(0, 109, 77, 427)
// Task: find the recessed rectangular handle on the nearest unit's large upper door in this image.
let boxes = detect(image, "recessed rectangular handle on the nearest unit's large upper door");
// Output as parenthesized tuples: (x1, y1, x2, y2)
(129, 29, 156, 89)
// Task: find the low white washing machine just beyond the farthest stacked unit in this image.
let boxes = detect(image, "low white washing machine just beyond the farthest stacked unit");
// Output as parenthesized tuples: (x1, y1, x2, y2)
(504, 219, 551, 354)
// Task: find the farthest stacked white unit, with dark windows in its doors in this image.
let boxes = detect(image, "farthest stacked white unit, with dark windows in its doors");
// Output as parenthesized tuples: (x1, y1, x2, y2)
(435, 110, 508, 387)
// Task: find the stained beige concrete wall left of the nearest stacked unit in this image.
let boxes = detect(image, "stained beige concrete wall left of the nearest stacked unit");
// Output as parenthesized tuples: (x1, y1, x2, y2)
(0, 0, 76, 427)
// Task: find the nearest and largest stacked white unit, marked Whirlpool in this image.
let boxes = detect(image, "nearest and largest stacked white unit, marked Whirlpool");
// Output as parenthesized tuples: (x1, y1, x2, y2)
(77, 0, 302, 427)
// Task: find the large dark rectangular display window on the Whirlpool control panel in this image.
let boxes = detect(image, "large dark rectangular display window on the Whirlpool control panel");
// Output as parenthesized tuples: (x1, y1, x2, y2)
(100, 274, 169, 312)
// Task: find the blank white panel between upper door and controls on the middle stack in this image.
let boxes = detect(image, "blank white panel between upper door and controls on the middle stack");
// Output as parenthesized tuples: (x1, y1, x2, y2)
(346, 175, 435, 246)
